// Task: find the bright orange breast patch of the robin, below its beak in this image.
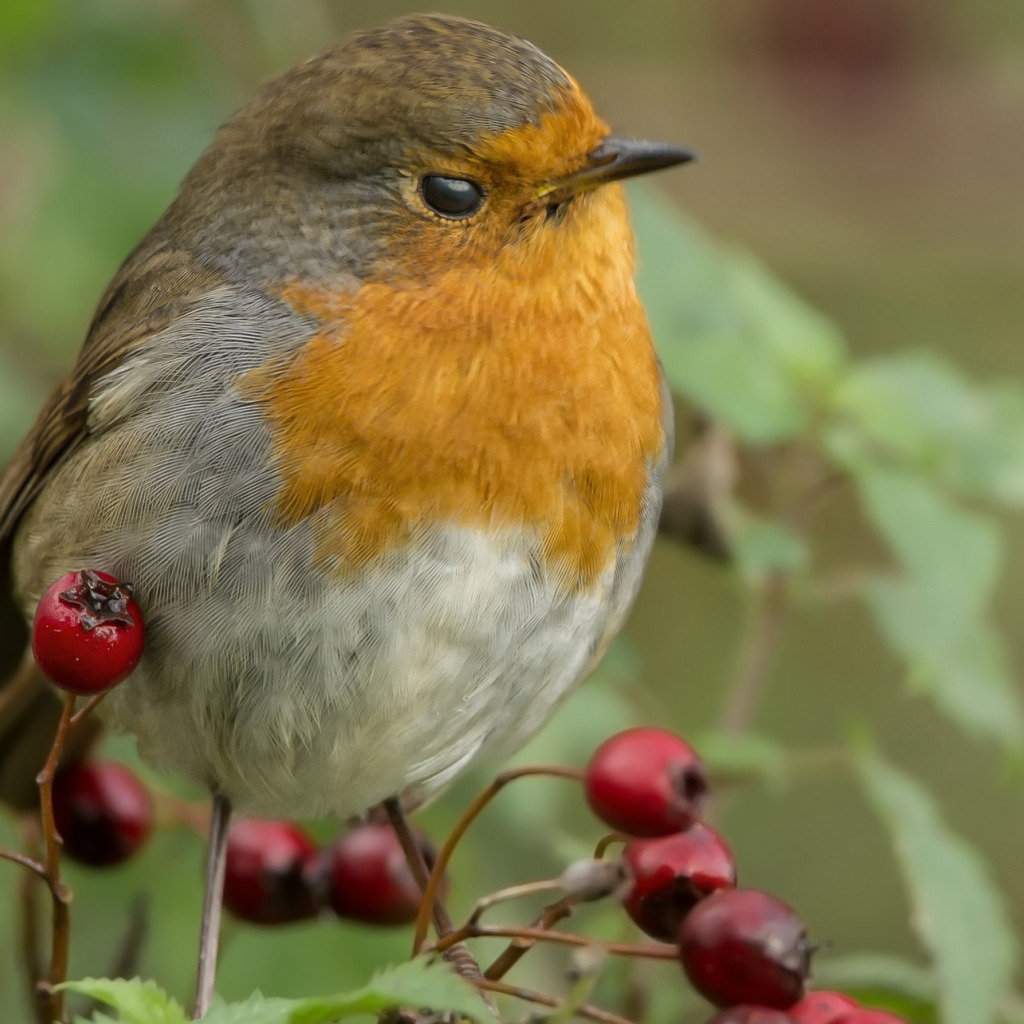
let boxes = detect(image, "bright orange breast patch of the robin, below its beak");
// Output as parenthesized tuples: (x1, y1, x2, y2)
(243, 180, 665, 588)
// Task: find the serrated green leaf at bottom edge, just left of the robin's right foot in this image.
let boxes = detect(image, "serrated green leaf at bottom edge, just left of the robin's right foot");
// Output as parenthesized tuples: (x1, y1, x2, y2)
(288, 957, 493, 1024)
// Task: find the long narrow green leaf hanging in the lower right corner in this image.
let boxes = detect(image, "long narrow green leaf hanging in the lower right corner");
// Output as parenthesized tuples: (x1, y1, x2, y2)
(857, 749, 1018, 1024)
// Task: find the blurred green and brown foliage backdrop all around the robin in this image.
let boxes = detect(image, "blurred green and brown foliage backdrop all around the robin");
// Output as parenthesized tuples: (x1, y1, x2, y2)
(0, 0, 1024, 1024)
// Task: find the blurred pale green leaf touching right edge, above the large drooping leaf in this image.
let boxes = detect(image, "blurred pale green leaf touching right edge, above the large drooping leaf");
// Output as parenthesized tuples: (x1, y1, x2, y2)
(835, 352, 1024, 506)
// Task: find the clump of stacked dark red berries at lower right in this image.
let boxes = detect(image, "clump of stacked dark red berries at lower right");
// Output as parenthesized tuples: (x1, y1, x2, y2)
(584, 728, 901, 1024)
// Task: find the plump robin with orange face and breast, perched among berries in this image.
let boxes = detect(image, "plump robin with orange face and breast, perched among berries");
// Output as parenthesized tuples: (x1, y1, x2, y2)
(0, 15, 690, 1002)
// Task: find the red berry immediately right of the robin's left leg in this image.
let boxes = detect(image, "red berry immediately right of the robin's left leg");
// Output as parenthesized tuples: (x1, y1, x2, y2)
(224, 818, 318, 925)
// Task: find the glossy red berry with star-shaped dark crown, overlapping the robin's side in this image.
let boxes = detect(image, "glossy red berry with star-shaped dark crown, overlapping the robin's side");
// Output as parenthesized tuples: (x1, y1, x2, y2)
(32, 569, 145, 696)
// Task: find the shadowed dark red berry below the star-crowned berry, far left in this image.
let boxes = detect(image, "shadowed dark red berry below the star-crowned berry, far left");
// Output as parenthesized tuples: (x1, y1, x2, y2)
(53, 761, 153, 867)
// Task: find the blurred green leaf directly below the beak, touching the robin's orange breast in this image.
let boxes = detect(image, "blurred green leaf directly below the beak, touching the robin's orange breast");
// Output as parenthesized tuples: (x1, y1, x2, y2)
(630, 186, 844, 443)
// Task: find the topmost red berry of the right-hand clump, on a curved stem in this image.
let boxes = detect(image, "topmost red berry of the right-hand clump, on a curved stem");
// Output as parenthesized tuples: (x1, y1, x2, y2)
(584, 729, 708, 836)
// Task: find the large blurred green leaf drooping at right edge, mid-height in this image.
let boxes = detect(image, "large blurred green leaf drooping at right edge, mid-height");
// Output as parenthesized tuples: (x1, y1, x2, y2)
(848, 458, 1024, 749)
